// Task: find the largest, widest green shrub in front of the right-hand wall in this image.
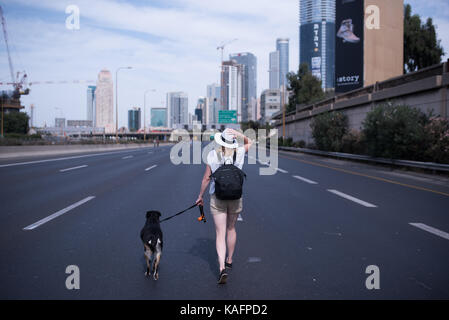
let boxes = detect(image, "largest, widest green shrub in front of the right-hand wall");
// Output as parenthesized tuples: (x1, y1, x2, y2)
(362, 104, 428, 161)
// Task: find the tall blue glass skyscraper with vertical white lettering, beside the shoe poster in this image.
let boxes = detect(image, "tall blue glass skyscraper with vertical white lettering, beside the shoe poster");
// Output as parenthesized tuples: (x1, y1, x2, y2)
(299, 0, 335, 89)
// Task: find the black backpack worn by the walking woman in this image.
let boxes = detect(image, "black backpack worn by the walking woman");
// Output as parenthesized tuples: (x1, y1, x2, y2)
(211, 150, 246, 200)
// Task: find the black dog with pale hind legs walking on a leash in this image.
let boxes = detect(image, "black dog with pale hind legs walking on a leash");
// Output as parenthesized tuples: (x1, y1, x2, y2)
(140, 211, 163, 280)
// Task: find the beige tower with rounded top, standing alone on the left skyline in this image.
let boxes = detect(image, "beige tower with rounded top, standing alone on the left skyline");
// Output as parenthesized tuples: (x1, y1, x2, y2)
(95, 70, 115, 133)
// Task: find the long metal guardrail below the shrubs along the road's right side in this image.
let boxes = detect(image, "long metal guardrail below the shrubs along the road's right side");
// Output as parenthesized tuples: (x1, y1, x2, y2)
(279, 147, 449, 172)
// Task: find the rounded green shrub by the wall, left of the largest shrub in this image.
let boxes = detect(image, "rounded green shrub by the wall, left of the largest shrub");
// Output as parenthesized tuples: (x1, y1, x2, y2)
(310, 111, 348, 152)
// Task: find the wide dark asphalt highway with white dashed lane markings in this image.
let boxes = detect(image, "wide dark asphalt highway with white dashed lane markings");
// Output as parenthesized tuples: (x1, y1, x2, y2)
(0, 146, 449, 299)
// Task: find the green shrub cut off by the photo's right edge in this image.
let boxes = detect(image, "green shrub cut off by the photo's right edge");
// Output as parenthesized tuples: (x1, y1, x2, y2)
(424, 118, 449, 163)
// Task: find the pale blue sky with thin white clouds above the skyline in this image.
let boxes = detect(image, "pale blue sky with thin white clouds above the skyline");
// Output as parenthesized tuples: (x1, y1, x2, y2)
(0, 0, 449, 126)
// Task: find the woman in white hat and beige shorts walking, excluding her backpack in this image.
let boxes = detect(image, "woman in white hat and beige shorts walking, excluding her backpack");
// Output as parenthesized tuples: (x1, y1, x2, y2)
(196, 128, 253, 284)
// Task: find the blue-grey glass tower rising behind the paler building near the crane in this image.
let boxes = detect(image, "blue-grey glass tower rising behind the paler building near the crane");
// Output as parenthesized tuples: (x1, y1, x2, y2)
(229, 52, 257, 122)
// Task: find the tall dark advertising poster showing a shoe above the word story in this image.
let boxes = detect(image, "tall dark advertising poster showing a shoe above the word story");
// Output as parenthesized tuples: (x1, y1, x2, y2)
(335, 0, 365, 93)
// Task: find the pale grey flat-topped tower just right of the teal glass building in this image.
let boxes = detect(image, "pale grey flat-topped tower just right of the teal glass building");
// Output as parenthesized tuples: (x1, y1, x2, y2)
(167, 92, 189, 128)
